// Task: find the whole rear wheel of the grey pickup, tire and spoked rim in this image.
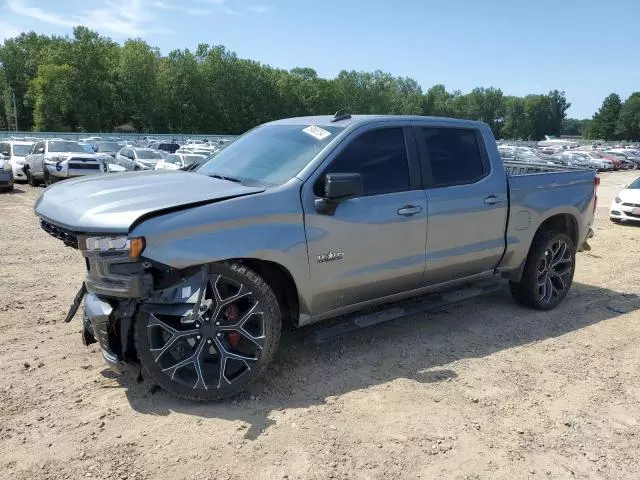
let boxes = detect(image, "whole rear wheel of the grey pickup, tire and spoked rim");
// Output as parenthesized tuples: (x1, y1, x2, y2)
(509, 231, 576, 310)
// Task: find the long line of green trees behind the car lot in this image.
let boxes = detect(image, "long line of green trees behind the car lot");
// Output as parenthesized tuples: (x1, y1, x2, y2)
(0, 27, 640, 140)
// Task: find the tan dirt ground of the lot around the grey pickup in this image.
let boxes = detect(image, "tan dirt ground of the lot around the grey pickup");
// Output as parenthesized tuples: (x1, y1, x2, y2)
(0, 172, 640, 480)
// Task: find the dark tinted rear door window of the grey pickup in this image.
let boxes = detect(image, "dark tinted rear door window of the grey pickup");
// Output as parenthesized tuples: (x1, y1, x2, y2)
(422, 128, 488, 187)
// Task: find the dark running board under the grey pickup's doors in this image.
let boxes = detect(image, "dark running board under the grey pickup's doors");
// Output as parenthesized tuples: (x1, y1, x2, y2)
(310, 279, 505, 343)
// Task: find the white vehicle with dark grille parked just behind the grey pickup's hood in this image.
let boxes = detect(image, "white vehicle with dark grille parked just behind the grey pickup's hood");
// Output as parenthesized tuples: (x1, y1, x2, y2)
(24, 139, 106, 186)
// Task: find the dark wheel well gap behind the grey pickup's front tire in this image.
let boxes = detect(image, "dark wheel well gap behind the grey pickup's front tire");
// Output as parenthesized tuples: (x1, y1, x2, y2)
(237, 258, 300, 327)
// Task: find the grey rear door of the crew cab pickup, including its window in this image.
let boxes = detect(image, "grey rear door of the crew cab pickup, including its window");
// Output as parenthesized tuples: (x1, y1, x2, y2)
(414, 127, 508, 285)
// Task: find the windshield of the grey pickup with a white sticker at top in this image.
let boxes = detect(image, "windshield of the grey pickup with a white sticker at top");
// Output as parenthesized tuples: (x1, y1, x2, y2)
(197, 124, 344, 185)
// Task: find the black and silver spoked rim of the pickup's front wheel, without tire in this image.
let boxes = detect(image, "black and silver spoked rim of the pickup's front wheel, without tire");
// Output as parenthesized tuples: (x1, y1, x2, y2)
(141, 269, 267, 390)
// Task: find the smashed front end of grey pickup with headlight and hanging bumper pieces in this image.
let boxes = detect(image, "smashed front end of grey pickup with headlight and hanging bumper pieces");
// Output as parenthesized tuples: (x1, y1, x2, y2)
(41, 219, 207, 372)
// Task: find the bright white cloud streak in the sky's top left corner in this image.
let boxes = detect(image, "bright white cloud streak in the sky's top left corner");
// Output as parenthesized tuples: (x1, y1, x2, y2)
(7, 0, 167, 37)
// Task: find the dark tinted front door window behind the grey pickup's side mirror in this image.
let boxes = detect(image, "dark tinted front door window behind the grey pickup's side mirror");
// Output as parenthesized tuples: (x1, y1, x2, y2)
(314, 128, 410, 196)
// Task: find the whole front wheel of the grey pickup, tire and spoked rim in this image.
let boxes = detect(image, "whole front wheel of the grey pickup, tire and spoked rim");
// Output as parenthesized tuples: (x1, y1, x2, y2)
(134, 263, 282, 401)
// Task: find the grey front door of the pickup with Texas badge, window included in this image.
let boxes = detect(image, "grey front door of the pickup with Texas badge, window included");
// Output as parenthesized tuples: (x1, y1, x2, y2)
(302, 125, 427, 317)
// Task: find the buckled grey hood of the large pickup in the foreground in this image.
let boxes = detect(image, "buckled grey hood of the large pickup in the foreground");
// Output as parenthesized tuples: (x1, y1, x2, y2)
(35, 170, 264, 233)
